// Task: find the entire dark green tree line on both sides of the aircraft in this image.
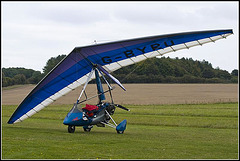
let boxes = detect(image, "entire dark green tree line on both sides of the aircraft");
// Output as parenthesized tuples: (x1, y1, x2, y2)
(2, 55, 238, 87)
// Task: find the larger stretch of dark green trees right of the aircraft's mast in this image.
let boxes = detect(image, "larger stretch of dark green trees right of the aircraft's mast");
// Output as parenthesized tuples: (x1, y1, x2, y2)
(113, 57, 238, 83)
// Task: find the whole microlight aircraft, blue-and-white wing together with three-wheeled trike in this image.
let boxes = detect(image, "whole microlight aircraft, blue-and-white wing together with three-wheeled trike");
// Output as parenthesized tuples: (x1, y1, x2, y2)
(8, 29, 233, 133)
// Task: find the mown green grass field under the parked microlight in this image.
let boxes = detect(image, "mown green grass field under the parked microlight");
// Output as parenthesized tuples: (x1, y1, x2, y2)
(2, 103, 239, 159)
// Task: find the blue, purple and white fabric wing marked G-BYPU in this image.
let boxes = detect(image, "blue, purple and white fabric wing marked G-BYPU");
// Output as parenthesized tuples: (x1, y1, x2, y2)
(8, 30, 233, 124)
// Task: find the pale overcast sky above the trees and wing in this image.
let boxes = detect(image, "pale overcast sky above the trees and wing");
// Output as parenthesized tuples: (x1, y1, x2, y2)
(1, 1, 239, 72)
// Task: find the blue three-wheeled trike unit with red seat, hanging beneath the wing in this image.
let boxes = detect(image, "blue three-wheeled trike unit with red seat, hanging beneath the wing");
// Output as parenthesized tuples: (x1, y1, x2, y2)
(63, 65, 130, 134)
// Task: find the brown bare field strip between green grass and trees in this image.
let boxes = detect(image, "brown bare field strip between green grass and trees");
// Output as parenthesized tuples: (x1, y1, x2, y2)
(2, 84, 238, 105)
